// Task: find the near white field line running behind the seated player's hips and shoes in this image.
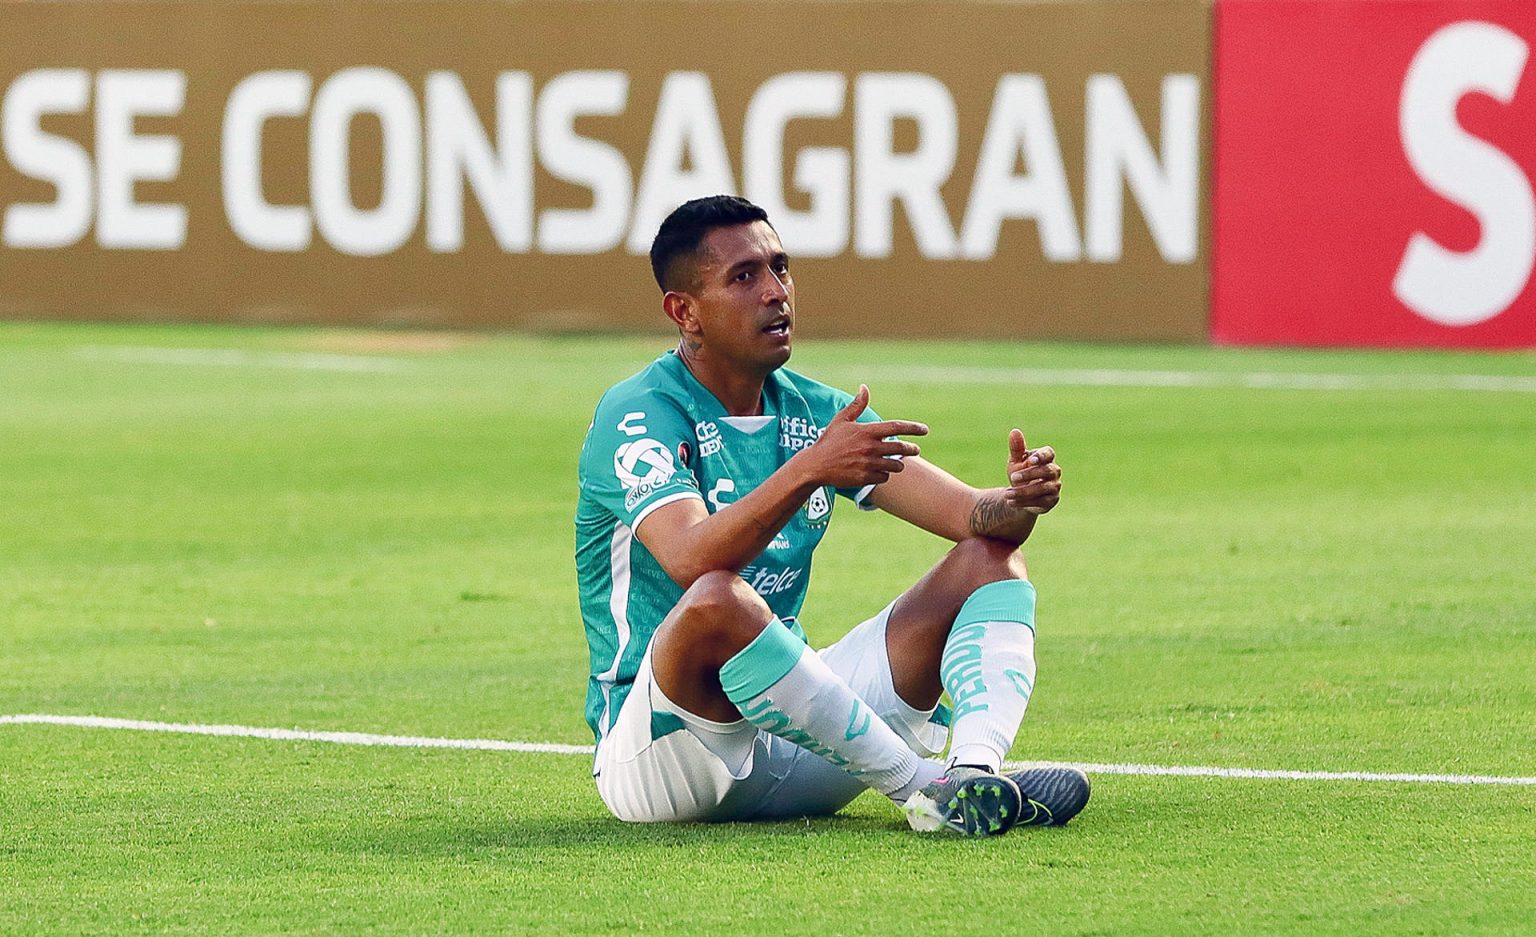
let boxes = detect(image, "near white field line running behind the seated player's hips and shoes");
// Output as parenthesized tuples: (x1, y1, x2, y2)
(0, 713, 1536, 786)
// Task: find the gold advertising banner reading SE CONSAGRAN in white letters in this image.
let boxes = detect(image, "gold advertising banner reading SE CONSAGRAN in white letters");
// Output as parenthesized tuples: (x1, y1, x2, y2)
(0, 0, 1210, 341)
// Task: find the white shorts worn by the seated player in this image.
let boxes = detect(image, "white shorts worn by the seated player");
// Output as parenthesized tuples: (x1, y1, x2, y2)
(594, 605, 949, 823)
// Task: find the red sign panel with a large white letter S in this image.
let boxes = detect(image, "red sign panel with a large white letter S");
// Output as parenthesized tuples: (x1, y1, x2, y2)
(1212, 0, 1536, 347)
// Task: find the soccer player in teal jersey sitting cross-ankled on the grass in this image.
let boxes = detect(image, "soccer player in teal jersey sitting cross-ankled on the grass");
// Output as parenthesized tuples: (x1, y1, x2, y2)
(576, 195, 1089, 834)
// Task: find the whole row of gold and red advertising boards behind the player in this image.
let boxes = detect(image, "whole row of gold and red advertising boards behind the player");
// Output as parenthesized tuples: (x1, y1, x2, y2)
(0, 0, 1536, 347)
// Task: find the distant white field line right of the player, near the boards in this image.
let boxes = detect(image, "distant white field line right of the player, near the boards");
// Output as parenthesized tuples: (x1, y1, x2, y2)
(880, 366, 1536, 393)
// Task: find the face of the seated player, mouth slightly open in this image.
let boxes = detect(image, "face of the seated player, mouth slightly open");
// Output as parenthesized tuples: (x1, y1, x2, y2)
(694, 221, 794, 373)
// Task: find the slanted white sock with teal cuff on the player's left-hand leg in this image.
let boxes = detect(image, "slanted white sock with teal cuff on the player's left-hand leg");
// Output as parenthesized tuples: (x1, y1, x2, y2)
(720, 619, 937, 803)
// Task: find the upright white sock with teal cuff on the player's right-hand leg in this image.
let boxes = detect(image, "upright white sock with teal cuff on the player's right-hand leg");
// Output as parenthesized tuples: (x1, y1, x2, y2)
(938, 579, 1035, 771)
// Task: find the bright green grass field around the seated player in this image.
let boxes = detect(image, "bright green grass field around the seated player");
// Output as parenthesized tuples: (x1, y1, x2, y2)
(0, 317, 1536, 935)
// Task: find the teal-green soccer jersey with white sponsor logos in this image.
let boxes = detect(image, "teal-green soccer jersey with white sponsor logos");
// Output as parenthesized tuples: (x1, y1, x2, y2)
(576, 352, 879, 742)
